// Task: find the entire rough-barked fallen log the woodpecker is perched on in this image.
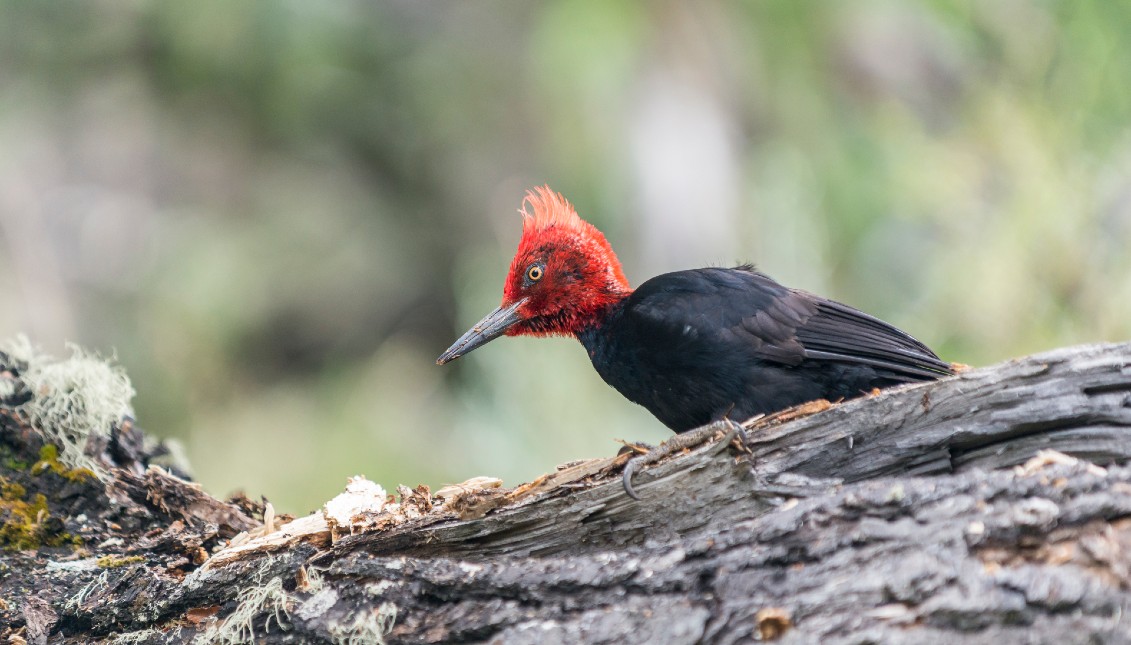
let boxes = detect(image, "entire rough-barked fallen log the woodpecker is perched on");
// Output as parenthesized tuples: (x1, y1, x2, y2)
(0, 344, 1131, 644)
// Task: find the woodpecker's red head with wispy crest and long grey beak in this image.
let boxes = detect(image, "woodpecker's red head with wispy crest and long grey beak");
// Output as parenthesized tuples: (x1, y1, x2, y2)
(437, 187, 632, 364)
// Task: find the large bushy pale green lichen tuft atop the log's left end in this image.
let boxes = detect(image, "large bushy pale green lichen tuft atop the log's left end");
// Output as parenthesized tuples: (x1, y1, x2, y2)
(0, 336, 135, 476)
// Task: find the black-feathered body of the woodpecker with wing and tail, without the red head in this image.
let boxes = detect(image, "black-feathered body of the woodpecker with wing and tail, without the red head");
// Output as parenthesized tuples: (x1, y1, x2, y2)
(577, 266, 952, 432)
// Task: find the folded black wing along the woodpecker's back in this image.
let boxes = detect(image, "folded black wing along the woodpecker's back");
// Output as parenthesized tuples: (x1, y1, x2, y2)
(625, 266, 952, 380)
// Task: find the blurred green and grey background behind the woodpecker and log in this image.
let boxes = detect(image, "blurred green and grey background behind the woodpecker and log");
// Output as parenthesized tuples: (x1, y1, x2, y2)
(0, 0, 1131, 513)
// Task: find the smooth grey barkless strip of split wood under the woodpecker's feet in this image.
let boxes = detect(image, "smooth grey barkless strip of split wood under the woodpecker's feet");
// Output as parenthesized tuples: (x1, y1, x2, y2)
(342, 344, 1131, 558)
